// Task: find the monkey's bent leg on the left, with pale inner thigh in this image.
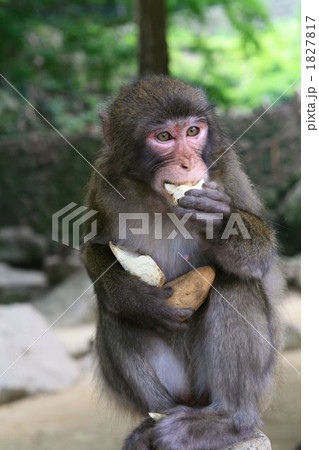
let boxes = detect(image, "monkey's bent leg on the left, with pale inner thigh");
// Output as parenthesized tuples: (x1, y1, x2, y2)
(96, 315, 189, 450)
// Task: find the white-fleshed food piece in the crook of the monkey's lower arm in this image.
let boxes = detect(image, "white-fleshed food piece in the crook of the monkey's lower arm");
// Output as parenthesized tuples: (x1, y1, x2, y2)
(109, 241, 165, 287)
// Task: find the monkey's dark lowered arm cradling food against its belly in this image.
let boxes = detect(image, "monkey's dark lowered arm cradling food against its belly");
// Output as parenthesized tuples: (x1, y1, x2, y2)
(82, 242, 193, 330)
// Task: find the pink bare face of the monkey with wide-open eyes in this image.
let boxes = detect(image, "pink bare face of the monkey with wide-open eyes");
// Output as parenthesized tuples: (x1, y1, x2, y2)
(147, 117, 208, 202)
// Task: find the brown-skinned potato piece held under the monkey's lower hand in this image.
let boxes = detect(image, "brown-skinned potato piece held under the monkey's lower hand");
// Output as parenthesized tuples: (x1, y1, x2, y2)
(163, 266, 216, 310)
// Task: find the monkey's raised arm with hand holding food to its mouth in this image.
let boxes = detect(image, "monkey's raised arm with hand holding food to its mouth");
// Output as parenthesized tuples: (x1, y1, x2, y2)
(179, 182, 276, 278)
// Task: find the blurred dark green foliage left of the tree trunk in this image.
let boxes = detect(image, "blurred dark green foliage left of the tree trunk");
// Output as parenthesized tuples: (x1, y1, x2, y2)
(0, 0, 137, 133)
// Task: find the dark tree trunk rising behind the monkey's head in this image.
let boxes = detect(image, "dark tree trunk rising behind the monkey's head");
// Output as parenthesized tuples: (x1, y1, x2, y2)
(135, 0, 168, 76)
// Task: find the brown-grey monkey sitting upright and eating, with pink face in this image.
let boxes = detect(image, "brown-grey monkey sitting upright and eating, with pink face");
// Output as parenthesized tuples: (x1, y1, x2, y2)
(81, 76, 282, 450)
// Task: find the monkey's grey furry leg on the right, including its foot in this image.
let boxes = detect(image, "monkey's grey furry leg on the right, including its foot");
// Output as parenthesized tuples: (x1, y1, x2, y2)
(152, 274, 275, 450)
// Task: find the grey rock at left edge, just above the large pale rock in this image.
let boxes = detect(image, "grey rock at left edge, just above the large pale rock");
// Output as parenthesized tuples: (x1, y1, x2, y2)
(0, 263, 47, 303)
